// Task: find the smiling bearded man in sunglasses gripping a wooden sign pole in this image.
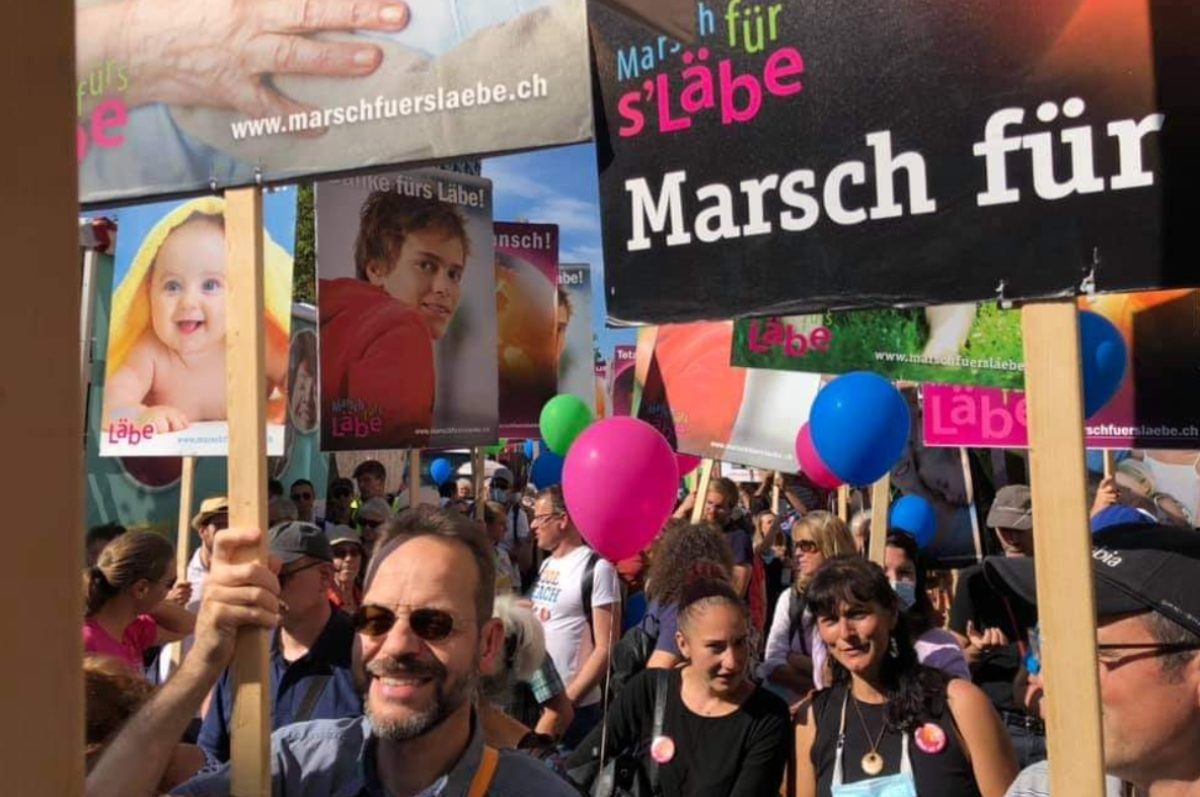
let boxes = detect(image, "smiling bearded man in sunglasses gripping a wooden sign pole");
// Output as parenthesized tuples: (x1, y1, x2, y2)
(86, 511, 577, 797)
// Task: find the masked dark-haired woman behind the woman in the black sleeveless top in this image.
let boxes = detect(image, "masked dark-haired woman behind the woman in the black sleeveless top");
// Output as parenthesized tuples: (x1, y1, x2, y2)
(883, 531, 971, 681)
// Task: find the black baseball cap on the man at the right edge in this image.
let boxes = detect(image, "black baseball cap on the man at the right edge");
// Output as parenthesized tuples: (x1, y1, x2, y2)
(984, 523, 1200, 634)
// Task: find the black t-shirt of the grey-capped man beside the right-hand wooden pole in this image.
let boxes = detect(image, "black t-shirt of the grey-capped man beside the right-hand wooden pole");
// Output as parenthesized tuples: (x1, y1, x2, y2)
(949, 564, 1038, 713)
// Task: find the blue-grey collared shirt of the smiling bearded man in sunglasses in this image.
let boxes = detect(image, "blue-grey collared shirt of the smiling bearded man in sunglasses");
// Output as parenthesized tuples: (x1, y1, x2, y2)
(173, 717, 578, 797)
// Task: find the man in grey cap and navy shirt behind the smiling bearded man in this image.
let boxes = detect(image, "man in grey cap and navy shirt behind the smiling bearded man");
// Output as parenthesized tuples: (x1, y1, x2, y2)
(197, 521, 362, 761)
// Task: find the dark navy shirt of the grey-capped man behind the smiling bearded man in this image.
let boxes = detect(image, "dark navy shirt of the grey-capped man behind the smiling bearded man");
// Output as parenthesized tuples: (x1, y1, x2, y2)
(197, 609, 362, 761)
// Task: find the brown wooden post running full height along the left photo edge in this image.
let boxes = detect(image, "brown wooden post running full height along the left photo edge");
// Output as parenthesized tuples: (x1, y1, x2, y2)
(0, 0, 82, 797)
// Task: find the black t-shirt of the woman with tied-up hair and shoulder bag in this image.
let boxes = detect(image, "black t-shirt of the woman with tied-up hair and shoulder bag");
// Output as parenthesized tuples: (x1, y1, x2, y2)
(566, 670, 792, 797)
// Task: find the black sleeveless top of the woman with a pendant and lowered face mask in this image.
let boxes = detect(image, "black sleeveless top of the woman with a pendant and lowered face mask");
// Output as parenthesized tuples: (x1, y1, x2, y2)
(811, 684, 979, 797)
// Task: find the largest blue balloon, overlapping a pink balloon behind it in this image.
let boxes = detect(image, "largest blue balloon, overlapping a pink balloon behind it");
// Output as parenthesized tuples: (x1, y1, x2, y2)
(809, 371, 910, 486)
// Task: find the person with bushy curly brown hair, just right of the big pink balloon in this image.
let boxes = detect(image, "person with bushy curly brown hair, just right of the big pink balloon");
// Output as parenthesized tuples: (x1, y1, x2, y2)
(642, 520, 733, 670)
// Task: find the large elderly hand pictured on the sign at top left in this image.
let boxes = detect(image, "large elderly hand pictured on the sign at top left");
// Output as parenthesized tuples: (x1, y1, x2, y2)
(77, 0, 409, 118)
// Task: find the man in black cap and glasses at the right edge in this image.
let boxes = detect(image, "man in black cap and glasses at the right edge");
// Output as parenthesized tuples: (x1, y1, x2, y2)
(985, 523, 1200, 797)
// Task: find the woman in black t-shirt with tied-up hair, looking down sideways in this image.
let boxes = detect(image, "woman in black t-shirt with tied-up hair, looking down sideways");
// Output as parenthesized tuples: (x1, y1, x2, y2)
(566, 577, 791, 797)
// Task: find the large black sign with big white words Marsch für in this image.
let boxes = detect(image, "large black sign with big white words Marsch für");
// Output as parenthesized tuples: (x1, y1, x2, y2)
(590, 0, 1200, 323)
